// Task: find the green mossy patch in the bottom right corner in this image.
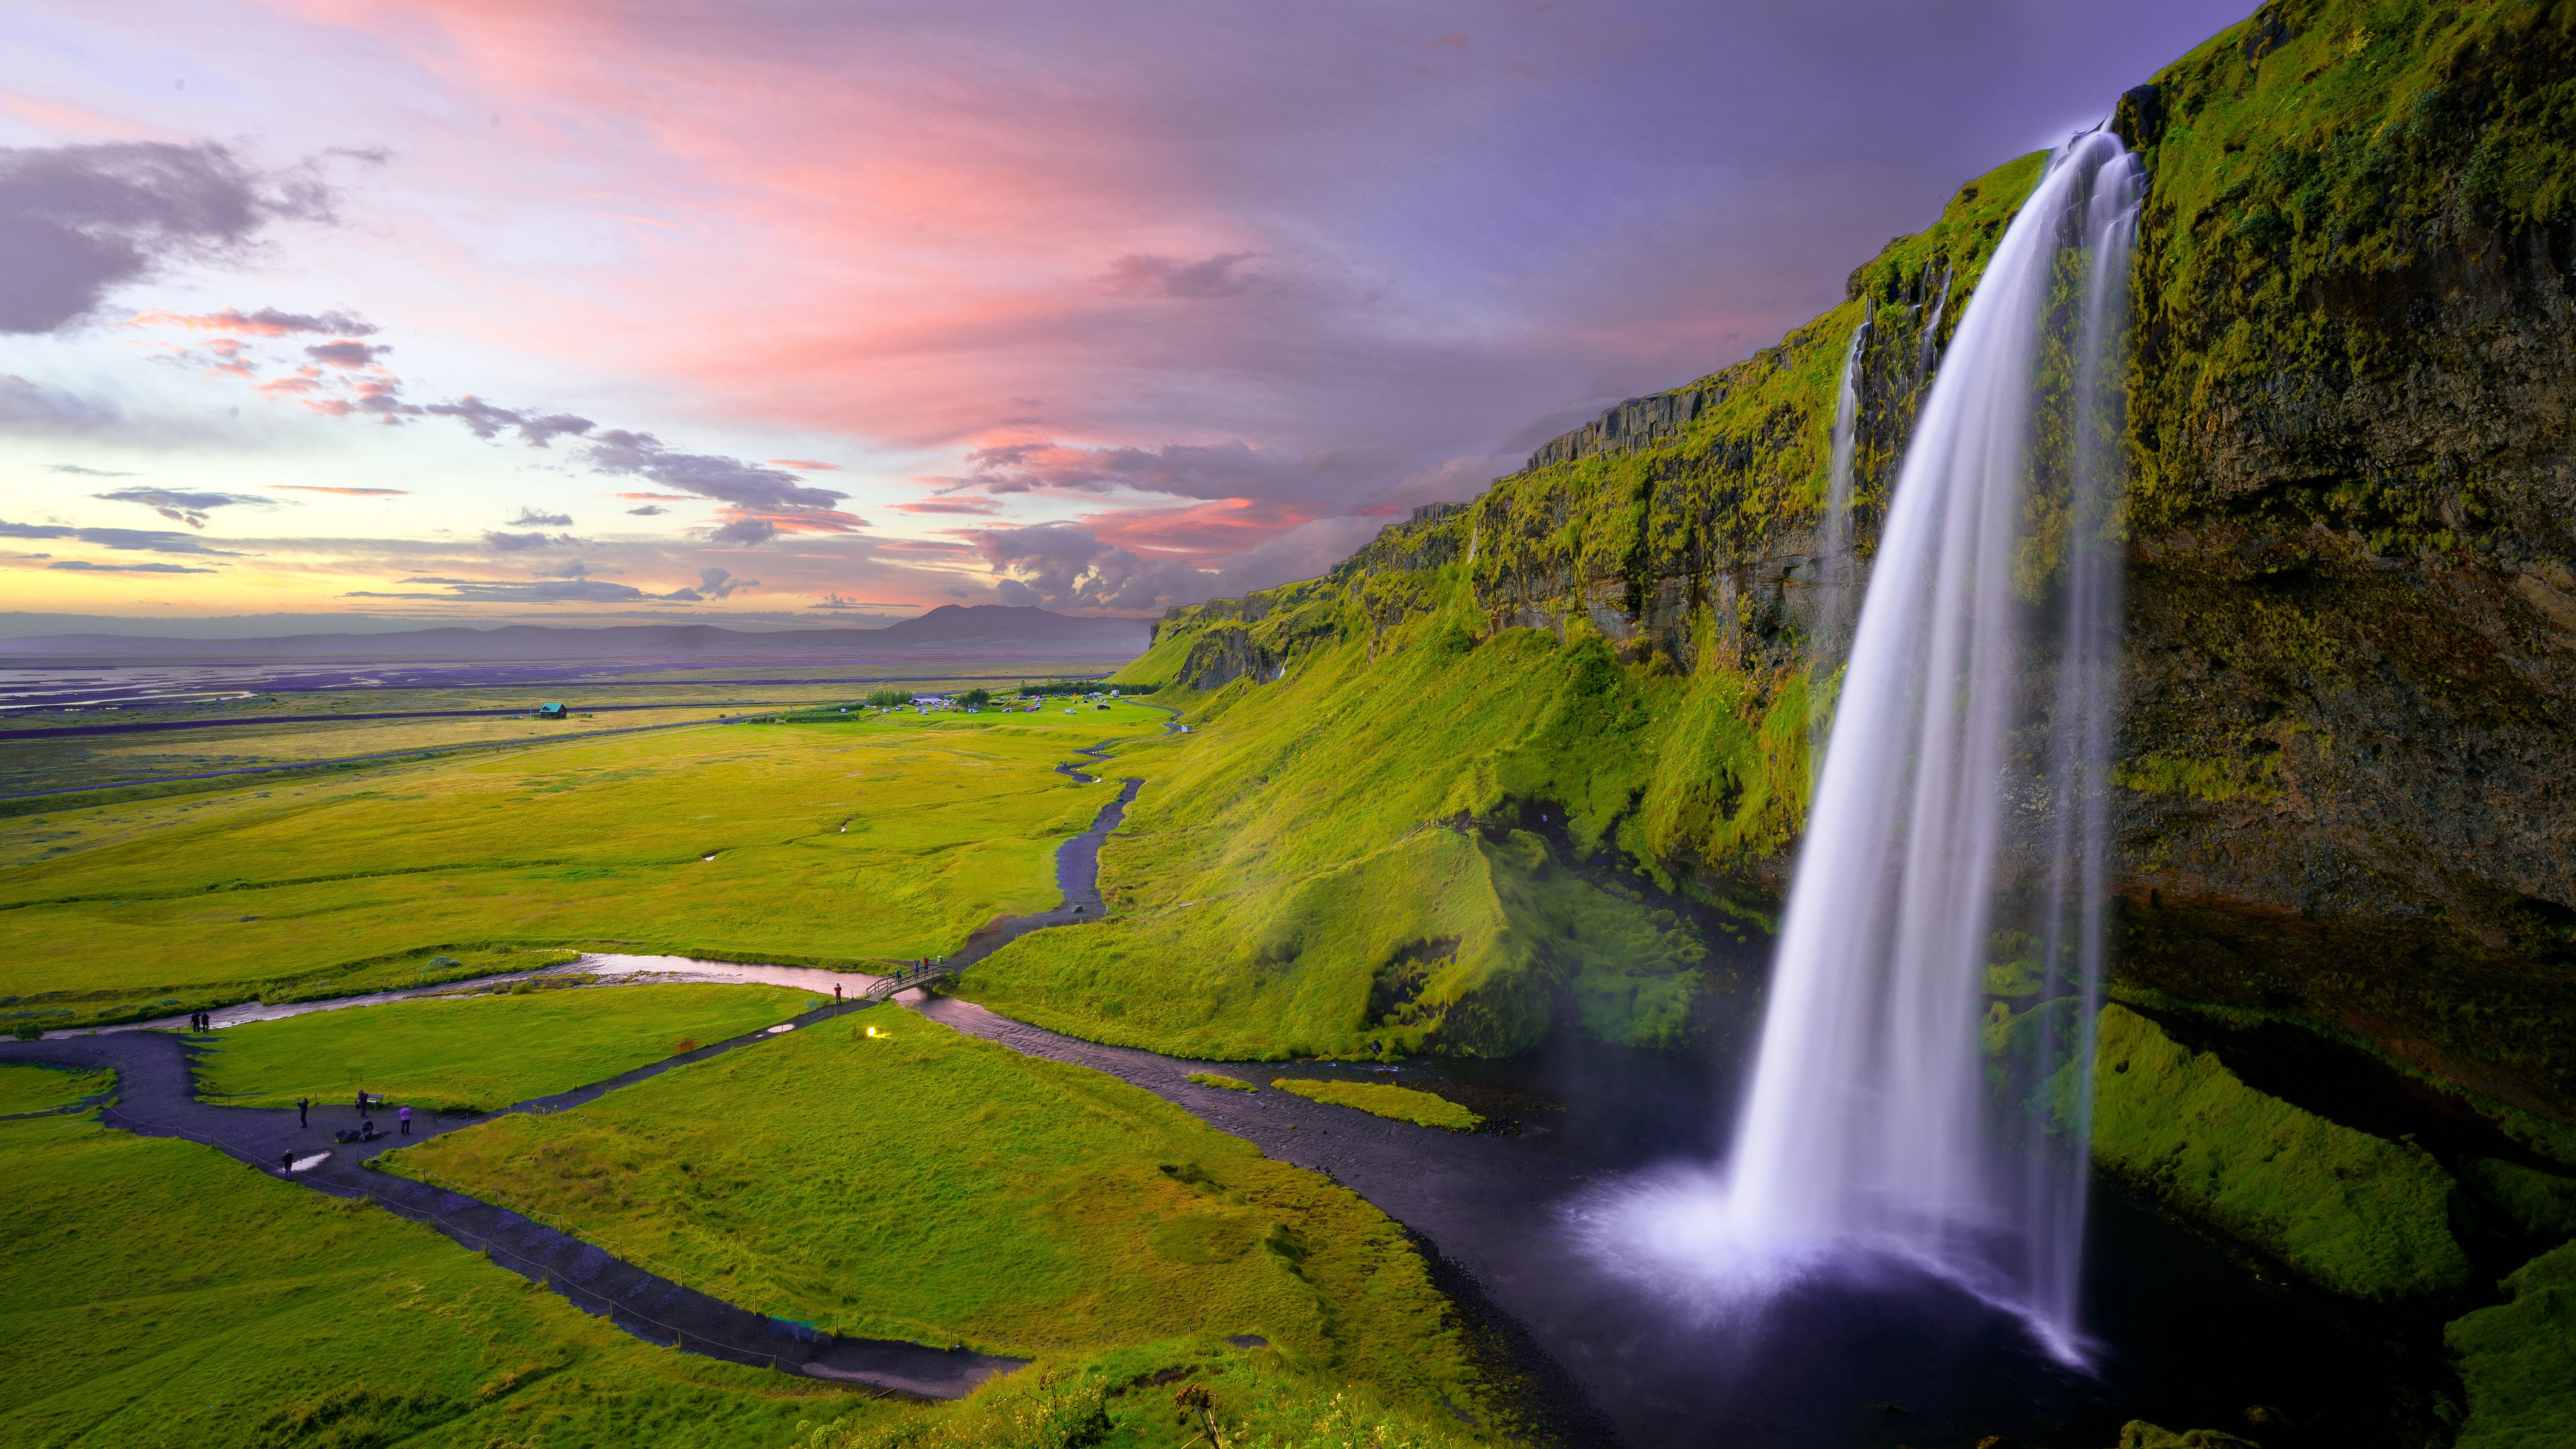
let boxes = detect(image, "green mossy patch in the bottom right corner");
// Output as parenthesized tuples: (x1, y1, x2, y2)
(2442, 1243, 2576, 1449)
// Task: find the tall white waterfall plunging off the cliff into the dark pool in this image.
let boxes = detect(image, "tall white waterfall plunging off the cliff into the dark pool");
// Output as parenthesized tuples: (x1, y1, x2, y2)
(1571, 131, 2141, 1364)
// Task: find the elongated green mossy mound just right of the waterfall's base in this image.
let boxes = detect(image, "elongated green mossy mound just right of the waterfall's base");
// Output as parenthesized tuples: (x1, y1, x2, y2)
(2092, 1006, 2468, 1299)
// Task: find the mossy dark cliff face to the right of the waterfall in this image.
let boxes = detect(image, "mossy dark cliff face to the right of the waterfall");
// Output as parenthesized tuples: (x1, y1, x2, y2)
(2120, 0, 2576, 1122)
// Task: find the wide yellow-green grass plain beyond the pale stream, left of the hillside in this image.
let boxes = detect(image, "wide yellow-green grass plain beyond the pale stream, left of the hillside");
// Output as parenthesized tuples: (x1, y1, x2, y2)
(0, 704, 1165, 1026)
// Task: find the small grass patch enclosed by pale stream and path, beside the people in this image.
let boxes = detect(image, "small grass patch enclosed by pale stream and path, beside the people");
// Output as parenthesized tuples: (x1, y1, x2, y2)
(196, 982, 822, 1112)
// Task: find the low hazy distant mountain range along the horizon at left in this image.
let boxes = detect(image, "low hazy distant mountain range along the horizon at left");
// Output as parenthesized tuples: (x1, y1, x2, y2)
(0, 603, 1151, 663)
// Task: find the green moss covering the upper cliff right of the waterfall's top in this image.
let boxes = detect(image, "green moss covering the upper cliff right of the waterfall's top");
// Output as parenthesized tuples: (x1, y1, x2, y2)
(2131, 0, 2576, 543)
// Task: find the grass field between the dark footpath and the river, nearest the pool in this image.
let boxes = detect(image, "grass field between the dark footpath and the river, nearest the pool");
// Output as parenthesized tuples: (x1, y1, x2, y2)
(381, 1011, 1481, 1408)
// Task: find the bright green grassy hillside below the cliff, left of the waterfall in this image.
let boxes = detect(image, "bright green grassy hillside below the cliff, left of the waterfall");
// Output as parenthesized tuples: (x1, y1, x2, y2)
(958, 606, 1806, 1057)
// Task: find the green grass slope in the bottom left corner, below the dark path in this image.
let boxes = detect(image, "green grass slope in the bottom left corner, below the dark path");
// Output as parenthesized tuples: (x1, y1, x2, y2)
(0, 1116, 894, 1449)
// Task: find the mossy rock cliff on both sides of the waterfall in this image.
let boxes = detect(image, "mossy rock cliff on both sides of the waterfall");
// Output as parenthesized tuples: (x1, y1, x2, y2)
(1149, 0, 2576, 1122)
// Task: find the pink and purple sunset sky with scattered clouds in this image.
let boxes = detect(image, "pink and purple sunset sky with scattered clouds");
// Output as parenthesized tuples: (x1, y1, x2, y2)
(0, 0, 2251, 627)
